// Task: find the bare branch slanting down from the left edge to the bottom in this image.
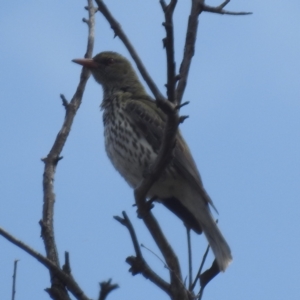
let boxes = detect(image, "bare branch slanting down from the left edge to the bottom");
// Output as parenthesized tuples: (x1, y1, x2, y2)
(0, 227, 90, 300)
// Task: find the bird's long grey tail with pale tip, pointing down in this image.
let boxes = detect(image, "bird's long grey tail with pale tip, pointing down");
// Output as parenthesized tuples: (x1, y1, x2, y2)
(197, 208, 232, 272)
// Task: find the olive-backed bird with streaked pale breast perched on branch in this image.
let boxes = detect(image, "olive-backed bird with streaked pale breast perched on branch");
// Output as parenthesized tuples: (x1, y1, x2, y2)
(72, 51, 232, 272)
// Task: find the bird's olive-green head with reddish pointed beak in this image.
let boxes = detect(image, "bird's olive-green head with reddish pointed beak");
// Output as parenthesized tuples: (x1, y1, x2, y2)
(73, 51, 146, 94)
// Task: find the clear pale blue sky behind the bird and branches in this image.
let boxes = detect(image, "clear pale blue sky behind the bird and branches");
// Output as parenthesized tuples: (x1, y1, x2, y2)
(0, 0, 300, 300)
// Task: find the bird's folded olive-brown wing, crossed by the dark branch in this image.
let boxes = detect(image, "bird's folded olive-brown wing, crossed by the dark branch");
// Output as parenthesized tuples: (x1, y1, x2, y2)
(125, 99, 217, 211)
